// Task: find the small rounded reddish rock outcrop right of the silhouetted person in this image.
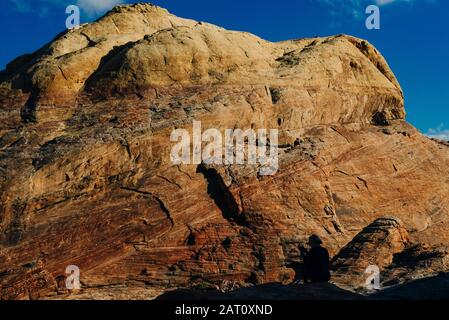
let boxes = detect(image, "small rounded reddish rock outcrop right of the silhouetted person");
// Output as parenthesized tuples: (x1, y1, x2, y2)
(332, 217, 449, 290)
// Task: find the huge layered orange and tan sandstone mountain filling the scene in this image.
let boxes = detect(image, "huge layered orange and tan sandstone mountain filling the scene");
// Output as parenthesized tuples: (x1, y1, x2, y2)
(0, 4, 449, 299)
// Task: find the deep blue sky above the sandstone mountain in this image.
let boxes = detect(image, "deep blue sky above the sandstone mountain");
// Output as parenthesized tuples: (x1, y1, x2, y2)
(0, 0, 449, 140)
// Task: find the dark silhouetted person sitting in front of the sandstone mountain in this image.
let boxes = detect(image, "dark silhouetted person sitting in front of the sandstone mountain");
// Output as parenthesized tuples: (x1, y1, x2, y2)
(299, 234, 331, 283)
